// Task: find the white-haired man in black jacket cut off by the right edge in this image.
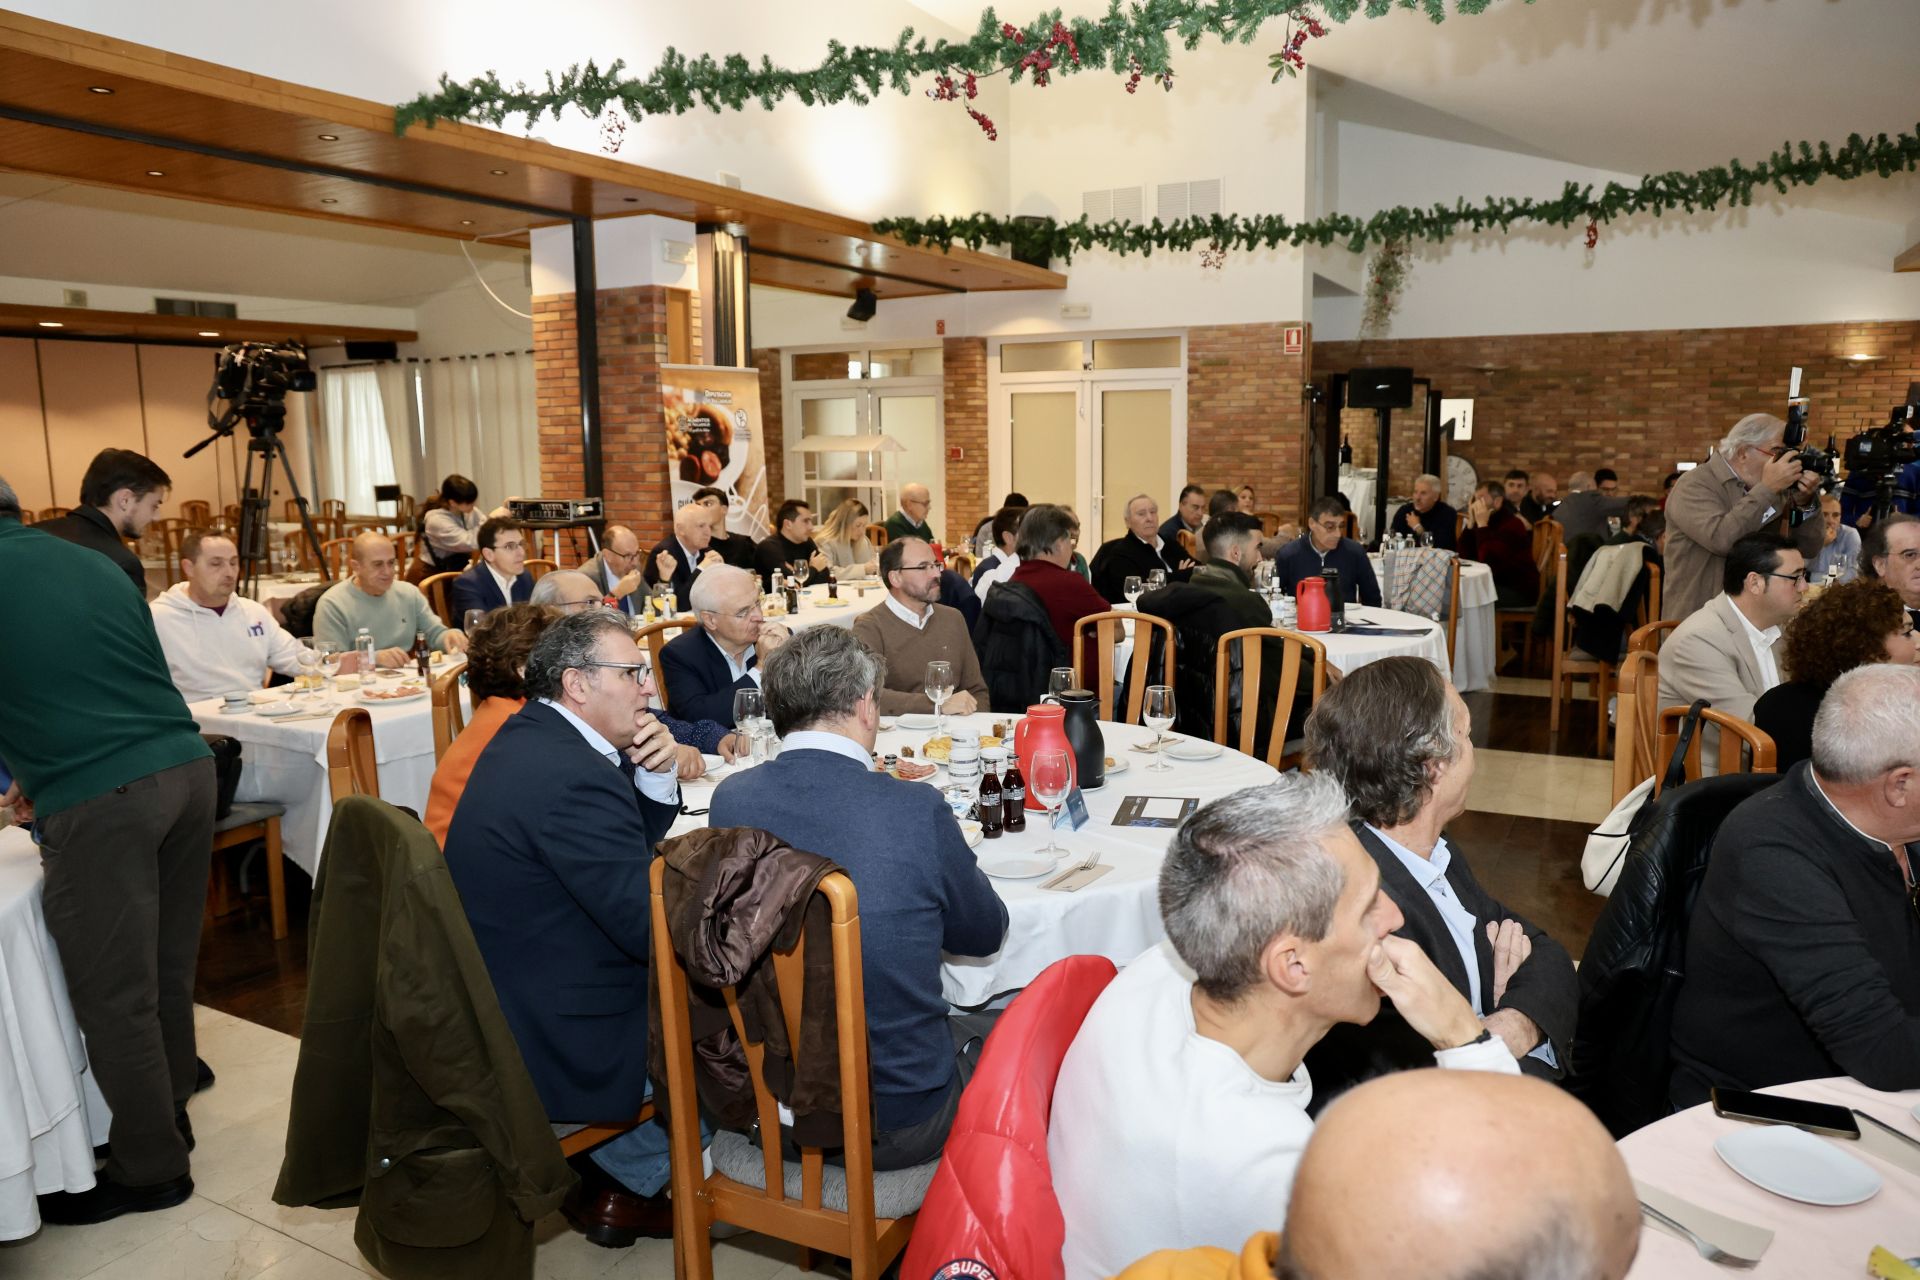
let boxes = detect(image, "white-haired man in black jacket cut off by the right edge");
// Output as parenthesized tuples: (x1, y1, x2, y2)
(1661, 667, 1920, 1107)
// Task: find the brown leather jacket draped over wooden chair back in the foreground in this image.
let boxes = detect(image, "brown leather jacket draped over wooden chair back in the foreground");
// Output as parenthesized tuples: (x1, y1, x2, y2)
(647, 827, 841, 1148)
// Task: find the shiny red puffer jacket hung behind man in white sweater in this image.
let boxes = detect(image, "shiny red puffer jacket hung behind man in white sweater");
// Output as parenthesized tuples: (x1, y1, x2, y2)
(900, 956, 1116, 1280)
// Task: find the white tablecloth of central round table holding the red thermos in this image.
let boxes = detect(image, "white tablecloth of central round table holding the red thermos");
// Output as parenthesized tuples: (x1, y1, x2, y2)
(672, 712, 1279, 1007)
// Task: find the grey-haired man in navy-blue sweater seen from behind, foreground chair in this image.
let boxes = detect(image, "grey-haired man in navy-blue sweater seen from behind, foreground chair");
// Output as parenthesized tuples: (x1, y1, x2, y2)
(710, 626, 1006, 1169)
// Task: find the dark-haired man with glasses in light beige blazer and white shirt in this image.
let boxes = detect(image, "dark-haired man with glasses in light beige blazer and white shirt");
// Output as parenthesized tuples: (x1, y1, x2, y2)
(1661, 533, 1807, 773)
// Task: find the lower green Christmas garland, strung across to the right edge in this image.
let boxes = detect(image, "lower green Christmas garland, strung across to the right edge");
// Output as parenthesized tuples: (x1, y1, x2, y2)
(874, 125, 1920, 261)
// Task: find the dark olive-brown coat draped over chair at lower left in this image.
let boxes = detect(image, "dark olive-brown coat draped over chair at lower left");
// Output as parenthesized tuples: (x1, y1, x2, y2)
(273, 796, 574, 1280)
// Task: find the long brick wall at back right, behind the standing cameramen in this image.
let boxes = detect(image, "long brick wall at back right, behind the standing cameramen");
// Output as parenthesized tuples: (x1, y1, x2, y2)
(1313, 320, 1920, 493)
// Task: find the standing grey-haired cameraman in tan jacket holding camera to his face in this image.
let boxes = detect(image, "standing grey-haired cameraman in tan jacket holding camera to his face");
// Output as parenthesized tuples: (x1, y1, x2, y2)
(1661, 413, 1826, 620)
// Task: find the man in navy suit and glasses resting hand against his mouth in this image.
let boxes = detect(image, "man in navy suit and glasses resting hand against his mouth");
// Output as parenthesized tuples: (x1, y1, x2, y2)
(445, 608, 680, 1245)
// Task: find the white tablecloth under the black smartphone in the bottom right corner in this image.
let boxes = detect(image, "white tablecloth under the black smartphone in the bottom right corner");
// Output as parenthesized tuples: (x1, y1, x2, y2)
(1620, 1077, 1920, 1280)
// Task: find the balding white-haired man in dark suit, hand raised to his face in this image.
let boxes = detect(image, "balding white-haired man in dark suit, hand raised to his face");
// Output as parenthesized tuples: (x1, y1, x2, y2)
(660, 564, 787, 723)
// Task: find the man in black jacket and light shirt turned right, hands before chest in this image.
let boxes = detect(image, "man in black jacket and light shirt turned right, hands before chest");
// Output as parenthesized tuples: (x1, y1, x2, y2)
(1308, 658, 1580, 1100)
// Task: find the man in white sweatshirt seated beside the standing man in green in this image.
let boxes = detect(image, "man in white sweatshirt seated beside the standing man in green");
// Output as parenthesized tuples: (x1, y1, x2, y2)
(152, 532, 300, 702)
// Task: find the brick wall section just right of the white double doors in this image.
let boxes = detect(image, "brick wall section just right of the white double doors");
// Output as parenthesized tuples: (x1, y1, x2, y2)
(1162, 320, 1319, 518)
